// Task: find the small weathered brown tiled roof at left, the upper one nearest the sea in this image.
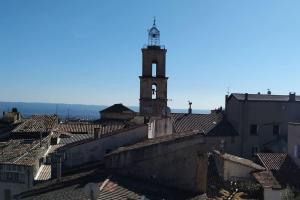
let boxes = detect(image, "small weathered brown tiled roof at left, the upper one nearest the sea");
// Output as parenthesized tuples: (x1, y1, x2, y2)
(12, 115, 58, 133)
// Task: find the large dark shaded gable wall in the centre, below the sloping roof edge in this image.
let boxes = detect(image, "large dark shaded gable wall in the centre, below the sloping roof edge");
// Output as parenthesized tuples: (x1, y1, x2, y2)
(105, 135, 239, 192)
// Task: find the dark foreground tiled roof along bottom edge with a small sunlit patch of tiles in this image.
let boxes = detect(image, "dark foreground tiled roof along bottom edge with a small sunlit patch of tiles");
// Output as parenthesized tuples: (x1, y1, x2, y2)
(20, 164, 202, 200)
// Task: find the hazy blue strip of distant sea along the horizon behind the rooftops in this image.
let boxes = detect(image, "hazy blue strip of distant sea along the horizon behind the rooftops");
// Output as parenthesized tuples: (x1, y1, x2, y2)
(0, 102, 210, 120)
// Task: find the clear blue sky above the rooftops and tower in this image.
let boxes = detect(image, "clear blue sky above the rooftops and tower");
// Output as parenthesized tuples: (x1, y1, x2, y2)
(0, 0, 300, 109)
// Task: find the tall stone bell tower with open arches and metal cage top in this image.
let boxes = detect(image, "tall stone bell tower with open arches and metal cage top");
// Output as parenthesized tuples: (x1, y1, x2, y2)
(140, 19, 168, 117)
